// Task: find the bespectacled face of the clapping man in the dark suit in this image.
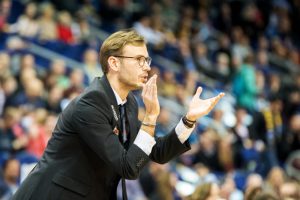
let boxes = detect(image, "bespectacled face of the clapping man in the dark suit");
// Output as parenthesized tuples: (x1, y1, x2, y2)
(117, 45, 151, 90)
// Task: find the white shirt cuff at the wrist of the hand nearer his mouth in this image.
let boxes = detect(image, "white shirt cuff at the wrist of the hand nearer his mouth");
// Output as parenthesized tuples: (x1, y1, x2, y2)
(134, 129, 156, 156)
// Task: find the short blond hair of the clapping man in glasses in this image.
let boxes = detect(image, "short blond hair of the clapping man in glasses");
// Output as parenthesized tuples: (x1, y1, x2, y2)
(100, 29, 146, 74)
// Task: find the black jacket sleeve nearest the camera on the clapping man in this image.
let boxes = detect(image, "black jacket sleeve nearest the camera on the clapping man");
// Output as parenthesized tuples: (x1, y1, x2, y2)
(72, 91, 149, 179)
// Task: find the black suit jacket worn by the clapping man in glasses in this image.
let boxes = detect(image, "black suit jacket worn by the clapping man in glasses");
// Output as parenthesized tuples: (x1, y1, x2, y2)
(13, 76, 190, 200)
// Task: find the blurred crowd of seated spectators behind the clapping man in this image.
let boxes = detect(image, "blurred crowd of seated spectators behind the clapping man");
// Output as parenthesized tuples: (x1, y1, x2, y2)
(0, 0, 300, 200)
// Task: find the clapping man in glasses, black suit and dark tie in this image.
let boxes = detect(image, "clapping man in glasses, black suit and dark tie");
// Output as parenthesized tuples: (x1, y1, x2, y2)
(13, 30, 224, 200)
